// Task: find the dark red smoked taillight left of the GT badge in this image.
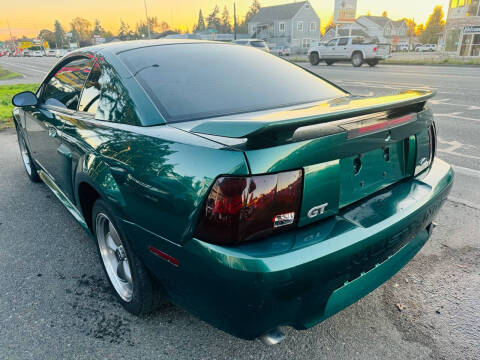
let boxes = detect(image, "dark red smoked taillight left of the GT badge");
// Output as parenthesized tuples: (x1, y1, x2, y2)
(195, 170, 303, 244)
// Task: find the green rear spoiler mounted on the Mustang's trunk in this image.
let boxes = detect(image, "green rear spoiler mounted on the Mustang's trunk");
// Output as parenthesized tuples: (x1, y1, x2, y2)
(184, 90, 435, 138)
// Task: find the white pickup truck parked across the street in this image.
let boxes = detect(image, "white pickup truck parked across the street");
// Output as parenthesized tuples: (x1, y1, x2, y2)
(308, 36, 391, 67)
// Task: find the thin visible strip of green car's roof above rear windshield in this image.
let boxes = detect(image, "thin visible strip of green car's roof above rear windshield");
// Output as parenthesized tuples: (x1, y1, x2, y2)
(76, 39, 219, 54)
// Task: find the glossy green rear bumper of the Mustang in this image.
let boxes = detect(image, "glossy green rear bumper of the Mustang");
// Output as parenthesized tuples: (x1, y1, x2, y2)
(125, 159, 453, 339)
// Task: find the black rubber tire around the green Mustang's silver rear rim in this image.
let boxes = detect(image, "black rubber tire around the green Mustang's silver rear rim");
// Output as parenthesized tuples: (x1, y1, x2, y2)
(92, 198, 168, 315)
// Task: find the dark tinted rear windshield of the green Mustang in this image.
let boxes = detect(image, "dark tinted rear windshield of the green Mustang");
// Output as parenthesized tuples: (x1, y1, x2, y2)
(119, 43, 345, 122)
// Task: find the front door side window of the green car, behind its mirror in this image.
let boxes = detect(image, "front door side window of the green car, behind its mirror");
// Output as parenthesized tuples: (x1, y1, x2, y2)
(41, 58, 92, 110)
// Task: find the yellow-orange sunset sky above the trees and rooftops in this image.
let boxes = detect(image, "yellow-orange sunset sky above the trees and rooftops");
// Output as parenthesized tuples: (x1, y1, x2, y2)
(0, 0, 449, 40)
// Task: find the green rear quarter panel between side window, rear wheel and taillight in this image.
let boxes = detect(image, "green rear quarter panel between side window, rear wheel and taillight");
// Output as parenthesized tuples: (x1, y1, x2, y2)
(66, 121, 249, 244)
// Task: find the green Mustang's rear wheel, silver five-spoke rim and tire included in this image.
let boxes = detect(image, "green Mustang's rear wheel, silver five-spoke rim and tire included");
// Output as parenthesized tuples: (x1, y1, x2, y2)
(92, 199, 166, 315)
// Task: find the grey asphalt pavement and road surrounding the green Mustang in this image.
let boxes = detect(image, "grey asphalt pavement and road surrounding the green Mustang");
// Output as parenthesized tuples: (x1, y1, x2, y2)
(0, 58, 480, 359)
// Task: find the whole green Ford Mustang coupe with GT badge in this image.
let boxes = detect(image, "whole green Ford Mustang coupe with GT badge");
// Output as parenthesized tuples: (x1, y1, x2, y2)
(13, 40, 454, 343)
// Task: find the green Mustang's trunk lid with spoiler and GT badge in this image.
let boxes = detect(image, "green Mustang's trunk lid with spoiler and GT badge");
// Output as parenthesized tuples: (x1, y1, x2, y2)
(172, 91, 433, 226)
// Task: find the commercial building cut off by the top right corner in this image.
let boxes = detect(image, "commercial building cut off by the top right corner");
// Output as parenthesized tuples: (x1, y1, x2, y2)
(445, 0, 480, 56)
